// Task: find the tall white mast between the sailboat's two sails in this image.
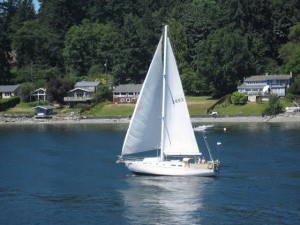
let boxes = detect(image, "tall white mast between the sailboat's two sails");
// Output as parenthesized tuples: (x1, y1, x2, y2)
(160, 25, 168, 161)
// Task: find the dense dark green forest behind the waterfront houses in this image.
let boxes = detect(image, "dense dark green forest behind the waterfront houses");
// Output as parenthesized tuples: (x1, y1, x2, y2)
(0, 0, 300, 99)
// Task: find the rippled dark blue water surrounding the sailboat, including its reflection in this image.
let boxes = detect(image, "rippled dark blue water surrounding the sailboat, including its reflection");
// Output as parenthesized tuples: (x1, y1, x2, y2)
(0, 123, 300, 225)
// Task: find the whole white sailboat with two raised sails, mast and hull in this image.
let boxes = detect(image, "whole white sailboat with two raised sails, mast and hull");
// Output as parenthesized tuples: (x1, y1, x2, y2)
(117, 25, 219, 176)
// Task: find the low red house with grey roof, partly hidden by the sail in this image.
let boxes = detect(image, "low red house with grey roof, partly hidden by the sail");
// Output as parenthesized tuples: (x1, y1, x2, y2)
(113, 84, 142, 103)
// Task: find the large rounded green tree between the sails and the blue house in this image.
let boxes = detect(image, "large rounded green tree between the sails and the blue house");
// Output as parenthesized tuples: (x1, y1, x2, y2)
(196, 29, 252, 96)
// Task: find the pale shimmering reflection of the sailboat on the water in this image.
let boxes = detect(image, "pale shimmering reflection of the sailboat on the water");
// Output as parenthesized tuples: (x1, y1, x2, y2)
(120, 176, 213, 224)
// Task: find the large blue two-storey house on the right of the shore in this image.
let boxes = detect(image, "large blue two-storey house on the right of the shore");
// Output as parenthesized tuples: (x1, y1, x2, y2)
(237, 74, 292, 102)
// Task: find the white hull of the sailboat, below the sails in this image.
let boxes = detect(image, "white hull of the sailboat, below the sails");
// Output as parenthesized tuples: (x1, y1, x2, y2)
(124, 158, 218, 177)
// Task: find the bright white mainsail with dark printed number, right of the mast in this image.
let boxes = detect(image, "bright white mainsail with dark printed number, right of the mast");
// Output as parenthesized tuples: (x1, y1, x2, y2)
(163, 38, 200, 155)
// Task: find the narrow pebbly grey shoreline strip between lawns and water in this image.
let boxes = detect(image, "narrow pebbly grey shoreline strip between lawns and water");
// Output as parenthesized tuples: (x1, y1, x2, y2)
(0, 113, 300, 126)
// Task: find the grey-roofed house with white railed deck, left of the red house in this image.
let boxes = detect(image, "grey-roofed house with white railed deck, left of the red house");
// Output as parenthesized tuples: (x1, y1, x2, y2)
(64, 81, 100, 105)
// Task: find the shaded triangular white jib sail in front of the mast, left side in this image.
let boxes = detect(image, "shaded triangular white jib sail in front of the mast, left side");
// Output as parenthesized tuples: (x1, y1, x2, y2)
(122, 39, 163, 155)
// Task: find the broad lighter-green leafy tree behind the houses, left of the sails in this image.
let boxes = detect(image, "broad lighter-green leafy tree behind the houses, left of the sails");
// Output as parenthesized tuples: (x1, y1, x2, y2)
(63, 20, 118, 75)
